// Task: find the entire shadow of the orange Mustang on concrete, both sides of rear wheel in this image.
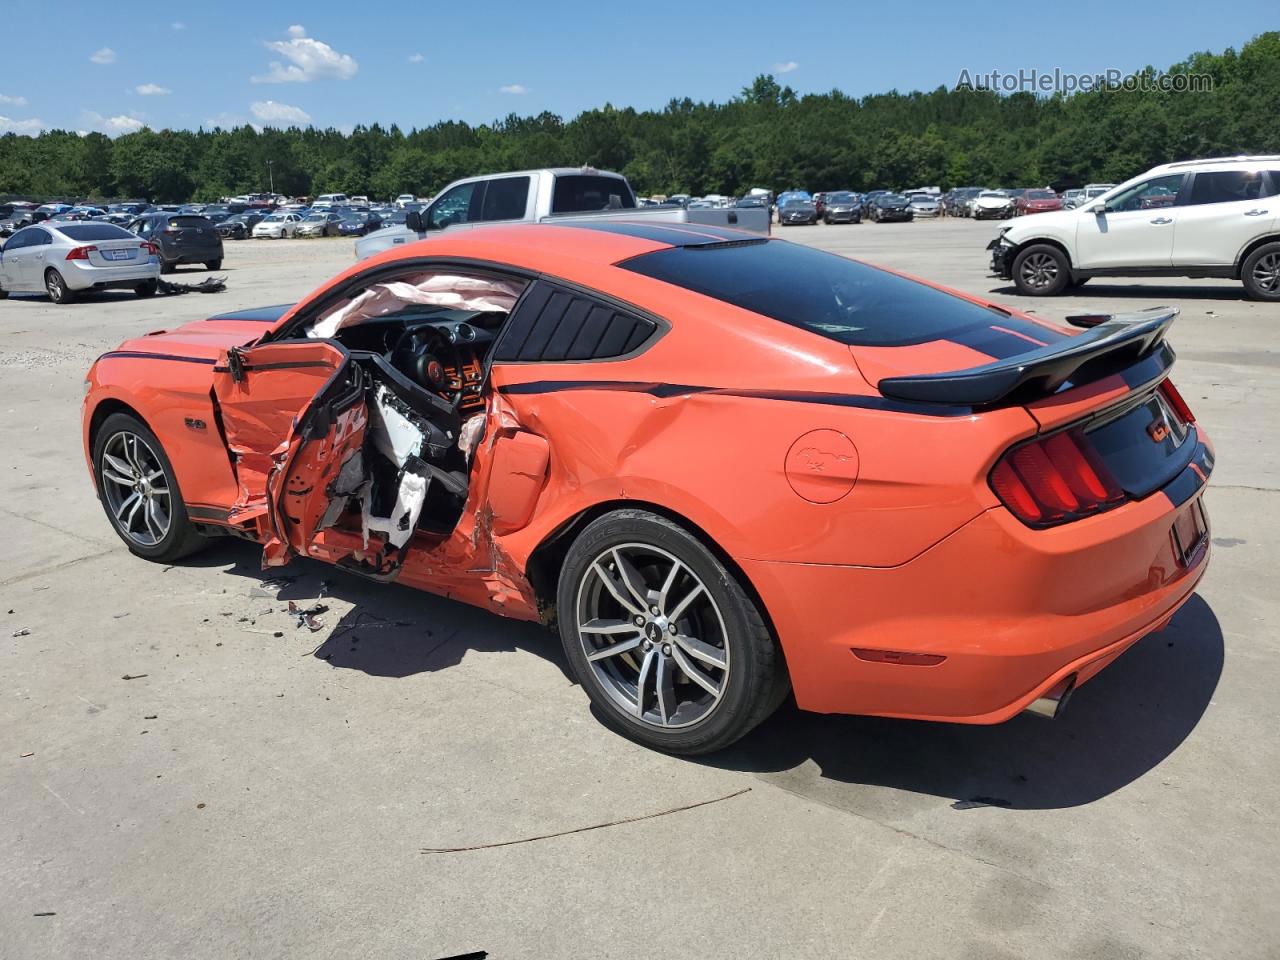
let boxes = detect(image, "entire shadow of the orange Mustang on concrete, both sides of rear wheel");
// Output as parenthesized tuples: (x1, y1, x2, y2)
(182, 540, 1224, 809)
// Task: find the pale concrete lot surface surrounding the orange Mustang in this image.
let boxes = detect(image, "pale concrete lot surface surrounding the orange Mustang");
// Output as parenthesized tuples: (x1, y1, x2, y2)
(0, 220, 1280, 960)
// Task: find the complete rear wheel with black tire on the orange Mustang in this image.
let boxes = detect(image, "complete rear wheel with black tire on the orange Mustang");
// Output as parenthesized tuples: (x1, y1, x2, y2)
(557, 509, 790, 756)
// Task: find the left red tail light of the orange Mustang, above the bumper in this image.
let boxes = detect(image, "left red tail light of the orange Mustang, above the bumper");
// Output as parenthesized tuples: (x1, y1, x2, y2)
(991, 428, 1125, 526)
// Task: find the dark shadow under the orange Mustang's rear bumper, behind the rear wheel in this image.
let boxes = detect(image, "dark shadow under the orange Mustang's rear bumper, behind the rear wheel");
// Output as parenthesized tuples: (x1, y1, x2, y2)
(701, 594, 1224, 810)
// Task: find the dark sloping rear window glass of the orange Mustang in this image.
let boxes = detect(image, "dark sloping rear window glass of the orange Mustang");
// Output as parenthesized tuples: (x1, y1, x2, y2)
(618, 241, 1004, 347)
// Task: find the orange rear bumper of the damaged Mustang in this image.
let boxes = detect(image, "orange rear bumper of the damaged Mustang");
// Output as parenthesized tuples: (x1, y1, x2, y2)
(740, 478, 1210, 723)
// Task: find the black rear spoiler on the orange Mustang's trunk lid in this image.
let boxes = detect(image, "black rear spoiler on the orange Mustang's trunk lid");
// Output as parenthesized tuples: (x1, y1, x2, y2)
(877, 307, 1178, 407)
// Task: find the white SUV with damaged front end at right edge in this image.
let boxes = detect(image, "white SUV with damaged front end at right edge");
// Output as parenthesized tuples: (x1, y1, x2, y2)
(987, 156, 1280, 302)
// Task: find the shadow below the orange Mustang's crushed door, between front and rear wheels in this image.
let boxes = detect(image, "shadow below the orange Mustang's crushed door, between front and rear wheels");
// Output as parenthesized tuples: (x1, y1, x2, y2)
(190, 539, 570, 686)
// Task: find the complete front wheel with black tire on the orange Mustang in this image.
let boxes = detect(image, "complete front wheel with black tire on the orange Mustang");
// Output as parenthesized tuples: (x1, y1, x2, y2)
(93, 413, 209, 563)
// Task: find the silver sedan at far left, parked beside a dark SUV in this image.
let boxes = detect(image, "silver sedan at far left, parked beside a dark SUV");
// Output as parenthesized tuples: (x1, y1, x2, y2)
(0, 221, 160, 303)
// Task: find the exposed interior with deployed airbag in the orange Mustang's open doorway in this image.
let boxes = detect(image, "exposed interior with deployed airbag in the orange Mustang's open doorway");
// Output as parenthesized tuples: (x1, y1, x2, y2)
(296, 273, 526, 548)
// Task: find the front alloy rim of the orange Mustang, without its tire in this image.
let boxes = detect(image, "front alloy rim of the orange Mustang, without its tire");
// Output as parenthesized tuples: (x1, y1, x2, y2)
(99, 430, 173, 547)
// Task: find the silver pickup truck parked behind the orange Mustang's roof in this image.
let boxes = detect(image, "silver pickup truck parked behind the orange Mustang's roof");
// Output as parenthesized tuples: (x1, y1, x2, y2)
(356, 166, 769, 260)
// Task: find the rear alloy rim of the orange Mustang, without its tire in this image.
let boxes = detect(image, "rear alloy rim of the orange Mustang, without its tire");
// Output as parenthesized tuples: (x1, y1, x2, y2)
(575, 543, 730, 730)
